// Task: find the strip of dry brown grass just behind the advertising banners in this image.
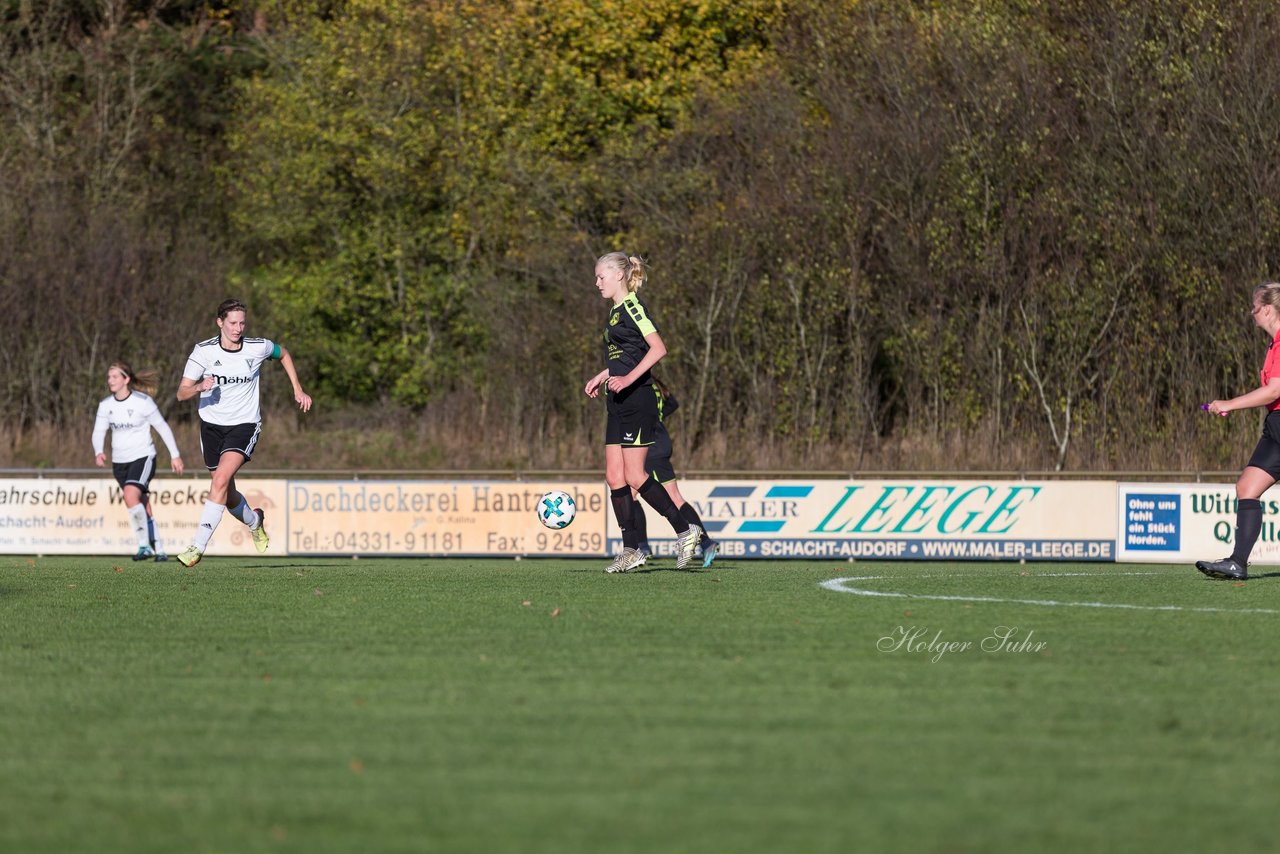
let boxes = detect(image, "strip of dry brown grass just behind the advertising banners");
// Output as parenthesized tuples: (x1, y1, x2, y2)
(0, 399, 1252, 478)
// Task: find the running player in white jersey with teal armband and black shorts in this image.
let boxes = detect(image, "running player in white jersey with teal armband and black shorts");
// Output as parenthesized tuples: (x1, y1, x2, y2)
(178, 300, 311, 566)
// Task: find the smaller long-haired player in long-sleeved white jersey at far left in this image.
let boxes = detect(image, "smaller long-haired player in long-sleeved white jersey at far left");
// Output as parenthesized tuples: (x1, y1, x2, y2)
(93, 362, 182, 561)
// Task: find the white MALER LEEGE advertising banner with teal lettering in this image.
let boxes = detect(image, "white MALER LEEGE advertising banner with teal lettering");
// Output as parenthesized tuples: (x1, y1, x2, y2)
(609, 480, 1116, 561)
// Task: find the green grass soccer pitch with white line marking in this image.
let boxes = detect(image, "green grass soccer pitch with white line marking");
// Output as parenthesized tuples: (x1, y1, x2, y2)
(0, 557, 1280, 851)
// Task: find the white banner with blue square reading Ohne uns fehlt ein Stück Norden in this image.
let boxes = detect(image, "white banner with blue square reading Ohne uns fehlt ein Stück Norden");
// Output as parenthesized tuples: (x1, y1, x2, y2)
(1116, 484, 1280, 563)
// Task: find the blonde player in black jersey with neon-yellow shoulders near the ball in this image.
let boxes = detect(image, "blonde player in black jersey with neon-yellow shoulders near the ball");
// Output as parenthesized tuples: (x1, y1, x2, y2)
(582, 252, 703, 572)
